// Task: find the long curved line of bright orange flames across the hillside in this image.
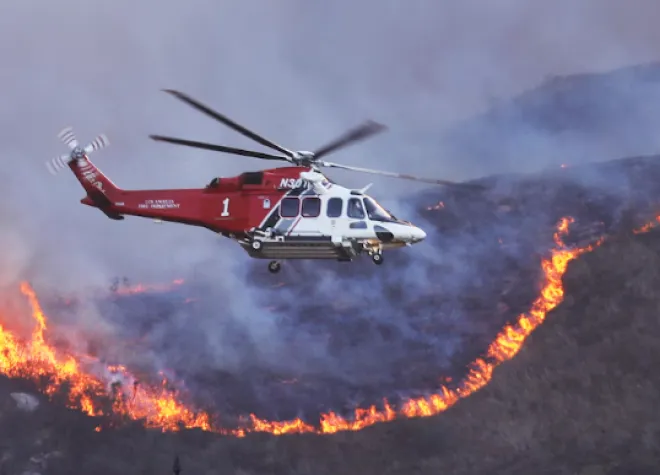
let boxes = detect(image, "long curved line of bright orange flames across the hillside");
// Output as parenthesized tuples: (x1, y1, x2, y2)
(0, 217, 640, 437)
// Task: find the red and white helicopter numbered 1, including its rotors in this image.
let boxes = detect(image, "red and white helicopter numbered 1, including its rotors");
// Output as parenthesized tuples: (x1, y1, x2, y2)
(46, 89, 481, 273)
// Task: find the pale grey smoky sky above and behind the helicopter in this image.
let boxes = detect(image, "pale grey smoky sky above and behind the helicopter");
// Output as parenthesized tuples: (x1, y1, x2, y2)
(0, 0, 660, 285)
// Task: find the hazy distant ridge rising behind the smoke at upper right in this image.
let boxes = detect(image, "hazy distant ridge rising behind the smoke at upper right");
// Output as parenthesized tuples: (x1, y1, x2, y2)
(439, 63, 660, 176)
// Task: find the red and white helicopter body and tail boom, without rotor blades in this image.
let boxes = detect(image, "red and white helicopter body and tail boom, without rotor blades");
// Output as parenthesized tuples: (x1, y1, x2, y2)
(69, 160, 426, 263)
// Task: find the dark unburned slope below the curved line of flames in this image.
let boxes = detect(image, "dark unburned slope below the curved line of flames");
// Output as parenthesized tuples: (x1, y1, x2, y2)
(0, 213, 660, 475)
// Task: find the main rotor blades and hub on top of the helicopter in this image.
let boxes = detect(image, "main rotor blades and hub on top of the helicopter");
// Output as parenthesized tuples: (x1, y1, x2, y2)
(149, 89, 484, 189)
